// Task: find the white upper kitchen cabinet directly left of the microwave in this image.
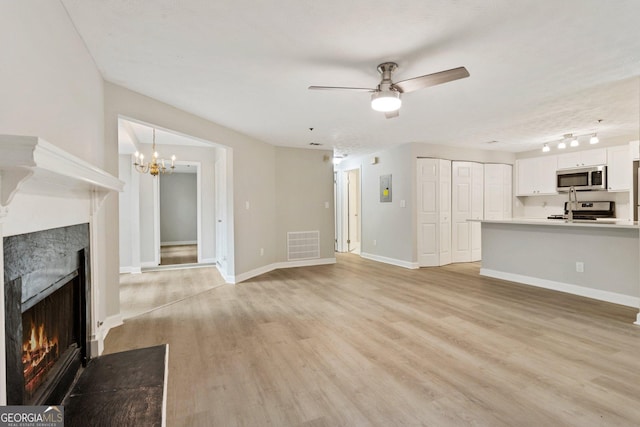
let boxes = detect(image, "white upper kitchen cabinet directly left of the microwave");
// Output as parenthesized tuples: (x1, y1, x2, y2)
(516, 155, 558, 196)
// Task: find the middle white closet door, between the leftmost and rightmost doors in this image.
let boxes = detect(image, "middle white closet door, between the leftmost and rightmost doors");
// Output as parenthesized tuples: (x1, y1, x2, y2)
(451, 161, 484, 262)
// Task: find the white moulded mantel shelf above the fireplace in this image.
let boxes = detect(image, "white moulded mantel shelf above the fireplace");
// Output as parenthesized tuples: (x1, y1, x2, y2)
(0, 135, 124, 217)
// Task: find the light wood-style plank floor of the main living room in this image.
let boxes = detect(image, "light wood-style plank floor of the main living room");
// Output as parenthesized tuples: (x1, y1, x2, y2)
(105, 254, 640, 427)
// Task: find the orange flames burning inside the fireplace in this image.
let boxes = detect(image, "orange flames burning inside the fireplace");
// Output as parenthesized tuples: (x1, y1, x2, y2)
(22, 323, 59, 390)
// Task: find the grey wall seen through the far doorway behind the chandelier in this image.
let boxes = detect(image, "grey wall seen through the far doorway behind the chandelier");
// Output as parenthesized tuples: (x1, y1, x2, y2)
(159, 173, 198, 245)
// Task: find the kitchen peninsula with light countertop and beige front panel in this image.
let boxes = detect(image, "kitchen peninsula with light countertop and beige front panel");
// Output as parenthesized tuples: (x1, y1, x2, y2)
(479, 218, 640, 324)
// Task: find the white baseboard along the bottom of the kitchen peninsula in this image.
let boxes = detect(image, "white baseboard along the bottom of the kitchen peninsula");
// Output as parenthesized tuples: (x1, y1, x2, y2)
(480, 268, 640, 310)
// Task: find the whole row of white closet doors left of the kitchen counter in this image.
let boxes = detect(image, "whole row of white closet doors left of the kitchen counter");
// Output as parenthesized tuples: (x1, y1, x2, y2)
(416, 159, 513, 267)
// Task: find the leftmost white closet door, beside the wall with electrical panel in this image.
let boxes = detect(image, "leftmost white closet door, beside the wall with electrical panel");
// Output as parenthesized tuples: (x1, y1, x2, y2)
(417, 159, 451, 267)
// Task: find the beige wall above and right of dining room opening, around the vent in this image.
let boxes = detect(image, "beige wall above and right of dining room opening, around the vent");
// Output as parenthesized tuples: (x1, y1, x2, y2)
(105, 83, 334, 277)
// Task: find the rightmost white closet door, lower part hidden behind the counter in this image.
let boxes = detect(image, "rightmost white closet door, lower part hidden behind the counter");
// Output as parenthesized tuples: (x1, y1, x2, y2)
(484, 163, 513, 219)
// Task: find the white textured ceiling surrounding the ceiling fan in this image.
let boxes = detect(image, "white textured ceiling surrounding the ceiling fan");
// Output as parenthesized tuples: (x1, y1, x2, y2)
(62, 0, 640, 155)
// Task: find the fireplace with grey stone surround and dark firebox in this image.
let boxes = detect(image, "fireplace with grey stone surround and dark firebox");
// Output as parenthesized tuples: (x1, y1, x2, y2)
(4, 224, 90, 405)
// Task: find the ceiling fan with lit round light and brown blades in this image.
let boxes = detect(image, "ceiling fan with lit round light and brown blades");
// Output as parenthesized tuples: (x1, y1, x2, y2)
(309, 62, 469, 119)
